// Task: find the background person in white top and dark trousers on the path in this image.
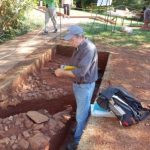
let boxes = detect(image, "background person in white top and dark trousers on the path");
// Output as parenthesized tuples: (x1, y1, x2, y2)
(62, 0, 73, 17)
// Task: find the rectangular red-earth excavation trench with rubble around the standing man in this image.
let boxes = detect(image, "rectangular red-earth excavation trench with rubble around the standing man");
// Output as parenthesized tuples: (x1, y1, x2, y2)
(0, 45, 109, 150)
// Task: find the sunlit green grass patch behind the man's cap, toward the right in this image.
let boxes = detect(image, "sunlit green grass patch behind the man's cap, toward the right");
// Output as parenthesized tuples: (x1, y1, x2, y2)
(81, 22, 150, 48)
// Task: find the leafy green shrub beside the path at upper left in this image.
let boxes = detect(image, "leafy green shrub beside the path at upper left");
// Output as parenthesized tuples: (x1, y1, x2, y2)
(0, 0, 33, 41)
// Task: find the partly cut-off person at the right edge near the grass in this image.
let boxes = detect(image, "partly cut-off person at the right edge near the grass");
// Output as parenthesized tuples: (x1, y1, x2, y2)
(141, 8, 150, 30)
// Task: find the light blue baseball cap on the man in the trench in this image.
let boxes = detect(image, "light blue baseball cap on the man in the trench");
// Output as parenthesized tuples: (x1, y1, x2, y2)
(64, 25, 84, 41)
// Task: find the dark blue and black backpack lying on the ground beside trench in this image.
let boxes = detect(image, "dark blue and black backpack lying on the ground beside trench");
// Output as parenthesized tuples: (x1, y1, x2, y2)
(96, 87, 150, 127)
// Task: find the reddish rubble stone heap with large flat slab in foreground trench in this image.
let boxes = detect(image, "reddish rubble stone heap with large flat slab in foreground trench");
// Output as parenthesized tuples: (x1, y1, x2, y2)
(0, 108, 71, 150)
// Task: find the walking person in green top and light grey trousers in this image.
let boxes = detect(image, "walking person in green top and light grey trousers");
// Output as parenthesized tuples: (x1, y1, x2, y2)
(44, 0, 57, 34)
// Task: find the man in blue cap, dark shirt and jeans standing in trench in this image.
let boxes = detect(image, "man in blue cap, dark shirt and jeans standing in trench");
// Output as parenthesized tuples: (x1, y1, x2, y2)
(55, 25, 98, 150)
